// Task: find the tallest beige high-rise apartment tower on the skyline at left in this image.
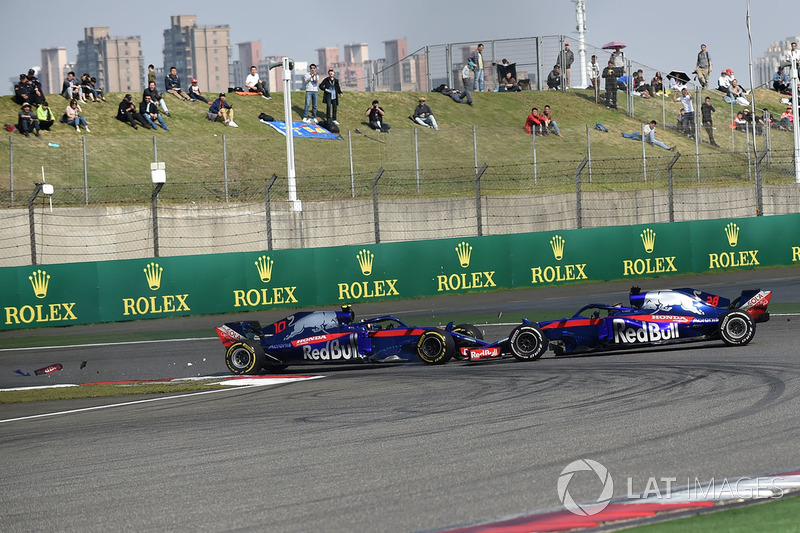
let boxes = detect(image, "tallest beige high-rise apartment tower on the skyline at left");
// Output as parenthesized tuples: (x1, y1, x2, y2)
(163, 15, 231, 93)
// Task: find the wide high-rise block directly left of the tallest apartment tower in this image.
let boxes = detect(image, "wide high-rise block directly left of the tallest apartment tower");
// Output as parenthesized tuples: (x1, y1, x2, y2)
(76, 26, 144, 92)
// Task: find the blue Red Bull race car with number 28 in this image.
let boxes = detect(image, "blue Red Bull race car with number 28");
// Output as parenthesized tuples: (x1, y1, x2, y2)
(496, 287, 772, 361)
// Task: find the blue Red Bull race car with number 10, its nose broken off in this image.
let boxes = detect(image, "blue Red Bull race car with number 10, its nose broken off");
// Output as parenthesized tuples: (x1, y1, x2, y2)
(216, 306, 488, 374)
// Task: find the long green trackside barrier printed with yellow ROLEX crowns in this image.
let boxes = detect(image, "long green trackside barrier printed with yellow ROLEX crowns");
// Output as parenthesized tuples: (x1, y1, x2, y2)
(0, 214, 800, 330)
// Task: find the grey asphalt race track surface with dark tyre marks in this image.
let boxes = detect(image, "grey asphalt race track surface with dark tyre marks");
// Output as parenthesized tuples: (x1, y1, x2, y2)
(0, 268, 800, 532)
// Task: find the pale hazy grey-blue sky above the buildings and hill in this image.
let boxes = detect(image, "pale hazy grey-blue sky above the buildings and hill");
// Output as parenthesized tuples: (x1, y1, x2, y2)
(0, 0, 800, 94)
